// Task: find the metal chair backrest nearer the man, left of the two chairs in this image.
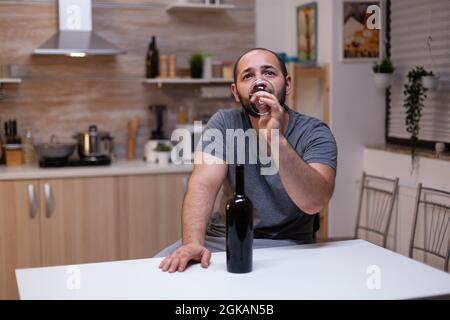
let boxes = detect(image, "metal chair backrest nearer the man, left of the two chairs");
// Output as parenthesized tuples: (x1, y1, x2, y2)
(355, 172, 399, 247)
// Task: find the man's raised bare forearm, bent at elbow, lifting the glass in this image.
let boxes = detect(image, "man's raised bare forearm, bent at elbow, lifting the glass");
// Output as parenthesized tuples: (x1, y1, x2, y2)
(272, 136, 333, 214)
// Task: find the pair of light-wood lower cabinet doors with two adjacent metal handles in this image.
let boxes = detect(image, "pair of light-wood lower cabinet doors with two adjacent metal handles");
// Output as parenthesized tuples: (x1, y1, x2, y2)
(0, 177, 119, 299)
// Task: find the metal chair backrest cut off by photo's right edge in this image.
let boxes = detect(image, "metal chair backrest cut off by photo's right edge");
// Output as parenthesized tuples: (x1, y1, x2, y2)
(409, 183, 450, 272)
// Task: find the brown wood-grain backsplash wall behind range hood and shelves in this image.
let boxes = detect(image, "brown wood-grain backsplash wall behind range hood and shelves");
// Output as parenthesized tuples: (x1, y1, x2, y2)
(0, 0, 255, 158)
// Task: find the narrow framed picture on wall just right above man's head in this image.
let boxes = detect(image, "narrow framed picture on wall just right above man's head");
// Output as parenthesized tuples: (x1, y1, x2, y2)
(297, 2, 318, 64)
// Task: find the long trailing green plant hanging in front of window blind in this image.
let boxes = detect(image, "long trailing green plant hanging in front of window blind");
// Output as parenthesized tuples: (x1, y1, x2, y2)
(403, 67, 430, 162)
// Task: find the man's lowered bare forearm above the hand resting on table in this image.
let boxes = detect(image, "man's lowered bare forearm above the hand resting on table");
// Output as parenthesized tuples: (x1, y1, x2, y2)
(182, 178, 217, 245)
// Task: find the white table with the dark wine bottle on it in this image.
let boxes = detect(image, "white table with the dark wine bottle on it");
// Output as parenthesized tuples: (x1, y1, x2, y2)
(16, 240, 450, 300)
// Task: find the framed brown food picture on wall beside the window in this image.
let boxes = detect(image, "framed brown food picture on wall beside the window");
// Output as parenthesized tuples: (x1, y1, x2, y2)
(341, 0, 383, 62)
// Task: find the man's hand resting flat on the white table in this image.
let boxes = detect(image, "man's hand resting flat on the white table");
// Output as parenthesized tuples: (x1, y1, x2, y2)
(159, 243, 211, 273)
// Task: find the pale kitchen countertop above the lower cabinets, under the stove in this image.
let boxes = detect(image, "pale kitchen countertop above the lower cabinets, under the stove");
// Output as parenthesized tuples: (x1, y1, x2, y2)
(0, 160, 193, 180)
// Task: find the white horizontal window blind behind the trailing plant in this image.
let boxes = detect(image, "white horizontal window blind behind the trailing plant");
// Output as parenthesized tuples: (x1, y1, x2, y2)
(388, 0, 450, 143)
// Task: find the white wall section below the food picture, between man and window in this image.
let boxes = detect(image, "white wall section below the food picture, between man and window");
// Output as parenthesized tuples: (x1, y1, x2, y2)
(329, 0, 385, 237)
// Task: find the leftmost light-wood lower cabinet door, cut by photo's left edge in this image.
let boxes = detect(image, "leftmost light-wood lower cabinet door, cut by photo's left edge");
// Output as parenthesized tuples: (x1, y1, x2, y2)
(0, 181, 41, 299)
